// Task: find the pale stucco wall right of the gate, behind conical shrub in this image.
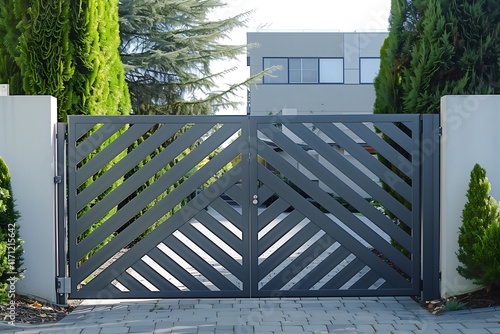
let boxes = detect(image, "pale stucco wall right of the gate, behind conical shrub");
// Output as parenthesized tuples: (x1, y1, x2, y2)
(440, 95, 500, 297)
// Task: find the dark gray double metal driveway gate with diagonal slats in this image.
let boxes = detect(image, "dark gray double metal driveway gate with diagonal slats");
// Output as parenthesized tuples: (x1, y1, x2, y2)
(59, 115, 439, 298)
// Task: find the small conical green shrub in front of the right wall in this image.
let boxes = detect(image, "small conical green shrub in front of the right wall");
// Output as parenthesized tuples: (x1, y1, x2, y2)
(457, 164, 500, 289)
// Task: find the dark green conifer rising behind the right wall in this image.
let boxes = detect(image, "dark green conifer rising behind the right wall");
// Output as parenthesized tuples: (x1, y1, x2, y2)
(374, 0, 500, 114)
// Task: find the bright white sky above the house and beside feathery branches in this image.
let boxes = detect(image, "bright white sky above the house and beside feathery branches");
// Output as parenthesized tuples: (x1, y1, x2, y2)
(212, 0, 391, 114)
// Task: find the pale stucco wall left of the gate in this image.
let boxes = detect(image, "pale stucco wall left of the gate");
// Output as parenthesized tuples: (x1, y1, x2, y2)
(0, 96, 57, 302)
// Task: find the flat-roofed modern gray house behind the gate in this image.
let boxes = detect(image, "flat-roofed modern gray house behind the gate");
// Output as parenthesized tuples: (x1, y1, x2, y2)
(247, 32, 388, 115)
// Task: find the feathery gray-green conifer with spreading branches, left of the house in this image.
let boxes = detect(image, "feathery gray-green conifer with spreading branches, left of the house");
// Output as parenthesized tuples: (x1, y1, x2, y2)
(119, 0, 253, 115)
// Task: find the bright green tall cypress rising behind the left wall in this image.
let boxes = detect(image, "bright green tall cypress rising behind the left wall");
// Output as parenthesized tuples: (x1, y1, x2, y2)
(0, 0, 130, 121)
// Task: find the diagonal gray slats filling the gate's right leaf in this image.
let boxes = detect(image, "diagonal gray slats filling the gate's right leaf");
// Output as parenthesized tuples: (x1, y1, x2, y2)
(252, 117, 419, 291)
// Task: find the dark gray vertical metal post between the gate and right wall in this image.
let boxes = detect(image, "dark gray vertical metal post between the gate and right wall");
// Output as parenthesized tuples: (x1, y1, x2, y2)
(420, 115, 440, 300)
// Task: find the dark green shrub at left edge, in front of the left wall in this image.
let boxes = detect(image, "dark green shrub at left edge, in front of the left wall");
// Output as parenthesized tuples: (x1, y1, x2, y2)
(0, 157, 23, 302)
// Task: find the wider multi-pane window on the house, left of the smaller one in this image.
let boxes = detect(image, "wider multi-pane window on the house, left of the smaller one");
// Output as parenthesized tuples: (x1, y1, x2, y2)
(263, 58, 344, 84)
